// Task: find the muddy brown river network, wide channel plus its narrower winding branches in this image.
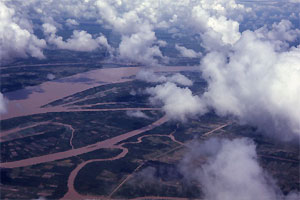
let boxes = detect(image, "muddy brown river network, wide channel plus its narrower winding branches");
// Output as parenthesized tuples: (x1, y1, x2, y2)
(0, 66, 199, 199)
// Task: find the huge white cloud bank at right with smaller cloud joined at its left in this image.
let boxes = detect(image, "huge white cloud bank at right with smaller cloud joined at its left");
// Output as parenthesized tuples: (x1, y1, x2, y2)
(134, 1, 300, 141)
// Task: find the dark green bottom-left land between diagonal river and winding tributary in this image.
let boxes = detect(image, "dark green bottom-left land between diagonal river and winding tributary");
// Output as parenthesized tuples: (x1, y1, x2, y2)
(0, 149, 121, 199)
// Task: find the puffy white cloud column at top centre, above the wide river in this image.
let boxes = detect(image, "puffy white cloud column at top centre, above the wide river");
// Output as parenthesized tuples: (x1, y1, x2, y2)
(95, 1, 163, 65)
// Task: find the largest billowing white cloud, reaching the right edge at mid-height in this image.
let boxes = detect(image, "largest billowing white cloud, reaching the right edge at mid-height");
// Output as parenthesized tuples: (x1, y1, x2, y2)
(201, 31, 300, 140)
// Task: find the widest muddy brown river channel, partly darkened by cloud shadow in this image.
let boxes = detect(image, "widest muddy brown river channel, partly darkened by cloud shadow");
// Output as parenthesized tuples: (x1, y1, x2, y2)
(1, 66, 196, 120)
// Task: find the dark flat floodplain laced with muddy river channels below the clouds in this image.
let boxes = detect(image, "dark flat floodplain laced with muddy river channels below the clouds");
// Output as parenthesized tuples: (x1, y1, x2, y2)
(0, 67, 299, 199)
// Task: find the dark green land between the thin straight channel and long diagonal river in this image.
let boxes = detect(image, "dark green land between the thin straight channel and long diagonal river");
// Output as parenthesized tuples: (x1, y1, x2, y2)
(1, 108, 161, 162)
